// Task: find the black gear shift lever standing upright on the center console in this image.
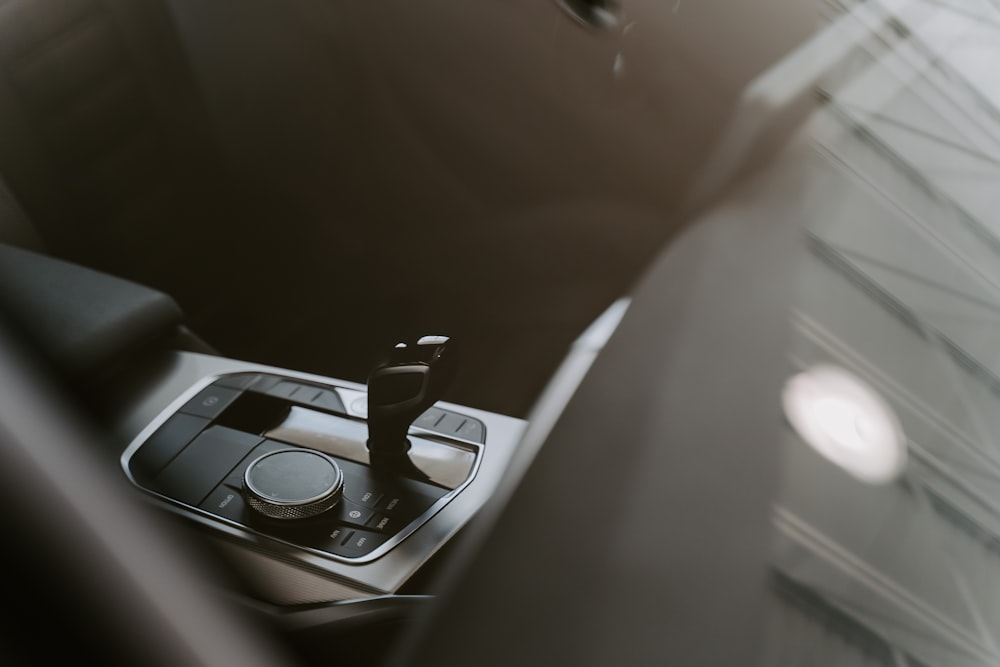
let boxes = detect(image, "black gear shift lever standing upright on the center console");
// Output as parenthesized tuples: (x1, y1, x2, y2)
(368, 336, 457, 467)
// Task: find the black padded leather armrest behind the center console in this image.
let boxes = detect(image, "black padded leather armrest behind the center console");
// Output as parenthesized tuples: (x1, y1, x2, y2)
(0, 244, 183, 379)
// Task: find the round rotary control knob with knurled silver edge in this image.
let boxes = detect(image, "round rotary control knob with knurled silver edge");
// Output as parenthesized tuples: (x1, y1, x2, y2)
(243, 449, 344, 519)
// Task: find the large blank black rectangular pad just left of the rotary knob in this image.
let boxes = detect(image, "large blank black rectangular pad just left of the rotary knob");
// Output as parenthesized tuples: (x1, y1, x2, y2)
(151, 426, 262, 505)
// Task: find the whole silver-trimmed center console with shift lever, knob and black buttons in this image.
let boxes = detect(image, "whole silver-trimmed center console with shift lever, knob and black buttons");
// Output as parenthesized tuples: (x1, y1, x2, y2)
(121, 336, 523, 604)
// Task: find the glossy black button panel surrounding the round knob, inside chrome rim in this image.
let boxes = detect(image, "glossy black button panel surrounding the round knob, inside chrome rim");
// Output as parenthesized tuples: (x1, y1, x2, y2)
(127, 373, 464, 559)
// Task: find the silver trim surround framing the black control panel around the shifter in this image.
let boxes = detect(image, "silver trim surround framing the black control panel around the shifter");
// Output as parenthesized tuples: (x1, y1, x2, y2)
(116, 352, 525, 603)
